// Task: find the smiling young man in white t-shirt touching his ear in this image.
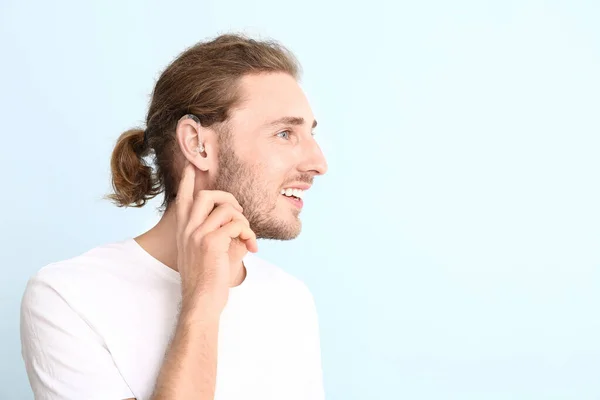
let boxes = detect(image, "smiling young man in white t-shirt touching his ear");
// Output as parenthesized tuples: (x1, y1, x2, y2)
(21, 35, 327, 400)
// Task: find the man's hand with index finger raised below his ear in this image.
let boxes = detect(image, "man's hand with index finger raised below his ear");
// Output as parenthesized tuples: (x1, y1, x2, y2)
(175, 162, 258, 314)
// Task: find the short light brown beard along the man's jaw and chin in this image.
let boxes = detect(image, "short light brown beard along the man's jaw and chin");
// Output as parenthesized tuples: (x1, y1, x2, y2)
(213, 143, 302, 240)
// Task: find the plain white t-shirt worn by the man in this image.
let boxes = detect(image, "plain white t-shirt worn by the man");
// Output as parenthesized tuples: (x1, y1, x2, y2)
(21, 239, 324, 400)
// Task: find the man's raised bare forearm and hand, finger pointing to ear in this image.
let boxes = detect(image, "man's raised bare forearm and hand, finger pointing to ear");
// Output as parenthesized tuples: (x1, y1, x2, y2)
(153, 164, 257, 400)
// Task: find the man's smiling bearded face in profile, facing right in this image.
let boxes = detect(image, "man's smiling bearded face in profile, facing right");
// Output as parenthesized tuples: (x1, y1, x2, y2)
(214, 73, 327, 240)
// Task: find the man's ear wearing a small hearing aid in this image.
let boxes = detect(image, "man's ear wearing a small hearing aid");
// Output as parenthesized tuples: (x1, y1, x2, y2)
(175, 117, 214, 171)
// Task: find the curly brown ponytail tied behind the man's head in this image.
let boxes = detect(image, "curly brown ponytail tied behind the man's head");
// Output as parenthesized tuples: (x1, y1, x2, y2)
(107, 129, 162, 207)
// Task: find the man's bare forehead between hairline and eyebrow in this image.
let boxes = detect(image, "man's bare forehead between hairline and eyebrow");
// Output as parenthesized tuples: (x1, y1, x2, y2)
(231, 73, 314, 128)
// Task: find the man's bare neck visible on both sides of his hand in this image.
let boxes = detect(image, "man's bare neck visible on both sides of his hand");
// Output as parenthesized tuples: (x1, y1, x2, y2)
(135, 207, 247, 287)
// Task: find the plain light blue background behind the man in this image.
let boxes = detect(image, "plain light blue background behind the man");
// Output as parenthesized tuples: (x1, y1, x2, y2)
(0, 0, 600, 400)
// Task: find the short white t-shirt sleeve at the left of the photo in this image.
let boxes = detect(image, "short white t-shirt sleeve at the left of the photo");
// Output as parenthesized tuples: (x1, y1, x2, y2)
(21, 276, 135, 400)
